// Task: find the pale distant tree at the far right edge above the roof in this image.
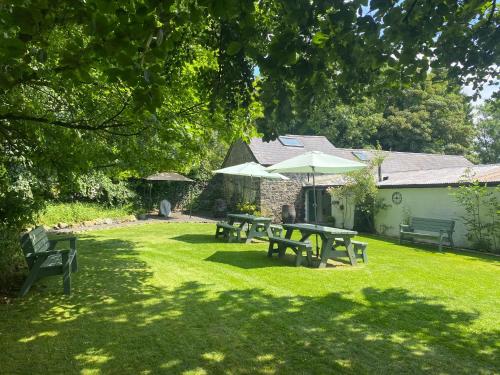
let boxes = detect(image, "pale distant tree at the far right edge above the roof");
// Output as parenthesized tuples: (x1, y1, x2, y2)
(475, 97, 500, 163)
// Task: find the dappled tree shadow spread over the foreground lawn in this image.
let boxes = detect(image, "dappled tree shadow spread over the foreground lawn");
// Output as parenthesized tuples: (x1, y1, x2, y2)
(0, 238, 500, 374)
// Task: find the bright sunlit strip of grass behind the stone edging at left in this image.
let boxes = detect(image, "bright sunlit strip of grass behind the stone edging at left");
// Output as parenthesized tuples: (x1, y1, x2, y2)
(38, 202, 132, 226)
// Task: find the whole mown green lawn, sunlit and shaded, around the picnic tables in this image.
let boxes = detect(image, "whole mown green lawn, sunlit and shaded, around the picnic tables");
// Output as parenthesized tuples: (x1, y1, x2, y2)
(0, 224, 500, 374)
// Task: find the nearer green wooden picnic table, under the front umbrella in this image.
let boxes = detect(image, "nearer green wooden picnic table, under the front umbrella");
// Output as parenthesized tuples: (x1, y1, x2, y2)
(283, 223, 358, 268)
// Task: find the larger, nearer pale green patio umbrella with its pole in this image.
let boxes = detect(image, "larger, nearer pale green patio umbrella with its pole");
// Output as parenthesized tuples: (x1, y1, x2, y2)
(266, 151, 366, 255)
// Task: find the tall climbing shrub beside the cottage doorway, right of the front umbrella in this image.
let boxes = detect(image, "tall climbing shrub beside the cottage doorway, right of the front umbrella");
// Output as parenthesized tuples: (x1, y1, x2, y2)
(327, 154, 387, 233)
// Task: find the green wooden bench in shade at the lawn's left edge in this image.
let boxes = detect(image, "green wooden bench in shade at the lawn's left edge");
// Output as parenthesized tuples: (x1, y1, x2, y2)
(19, 227, 78, 297)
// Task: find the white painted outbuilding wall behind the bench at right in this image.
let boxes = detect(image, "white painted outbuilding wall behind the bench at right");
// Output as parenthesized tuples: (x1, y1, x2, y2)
(375, 187, 500, 247)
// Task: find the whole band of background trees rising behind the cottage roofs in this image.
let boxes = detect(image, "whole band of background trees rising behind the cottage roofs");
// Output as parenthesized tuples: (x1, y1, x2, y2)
(298, 79, 475, 154)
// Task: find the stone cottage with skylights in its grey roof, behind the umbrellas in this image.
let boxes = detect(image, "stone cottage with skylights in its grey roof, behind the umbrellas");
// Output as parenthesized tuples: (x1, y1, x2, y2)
(222, 135, 472, 224)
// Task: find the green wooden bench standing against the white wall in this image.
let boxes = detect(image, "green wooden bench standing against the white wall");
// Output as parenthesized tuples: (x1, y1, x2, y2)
(399, 217, 455, 251)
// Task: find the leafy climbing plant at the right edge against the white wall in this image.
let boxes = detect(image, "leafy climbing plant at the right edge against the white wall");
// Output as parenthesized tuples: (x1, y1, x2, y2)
(450, 172, 500, 252)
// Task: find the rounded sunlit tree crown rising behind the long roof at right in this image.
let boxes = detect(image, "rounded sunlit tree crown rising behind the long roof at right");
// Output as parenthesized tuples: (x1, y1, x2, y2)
(372, 81, 475, 155)
